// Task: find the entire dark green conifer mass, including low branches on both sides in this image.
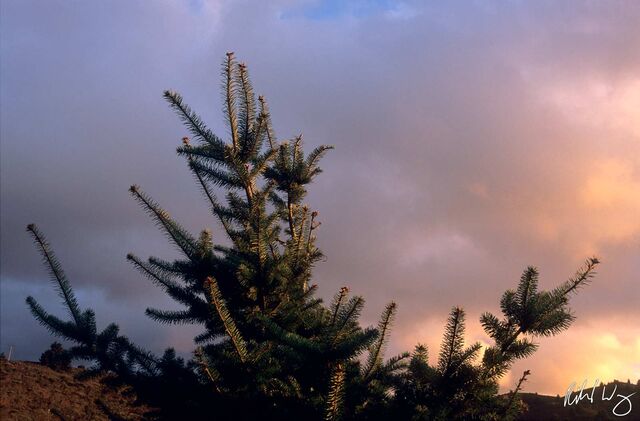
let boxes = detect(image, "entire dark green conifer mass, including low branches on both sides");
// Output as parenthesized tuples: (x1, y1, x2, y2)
(22, 53, 598, 420)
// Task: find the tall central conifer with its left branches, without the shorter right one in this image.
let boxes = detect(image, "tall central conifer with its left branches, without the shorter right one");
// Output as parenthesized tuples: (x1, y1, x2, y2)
(27, 53, 401, 419)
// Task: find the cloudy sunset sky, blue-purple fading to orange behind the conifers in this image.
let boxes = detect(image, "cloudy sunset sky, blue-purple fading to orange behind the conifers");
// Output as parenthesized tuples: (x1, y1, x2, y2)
(0, 0, 640, 395)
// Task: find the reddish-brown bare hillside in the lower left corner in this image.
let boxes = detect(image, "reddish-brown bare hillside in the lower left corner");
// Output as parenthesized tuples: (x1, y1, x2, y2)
(0, 359, 154, 421)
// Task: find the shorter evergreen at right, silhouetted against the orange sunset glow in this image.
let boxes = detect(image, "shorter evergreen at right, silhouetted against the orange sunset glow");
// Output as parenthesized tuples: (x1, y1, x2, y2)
(392, 258, 599, 420)
